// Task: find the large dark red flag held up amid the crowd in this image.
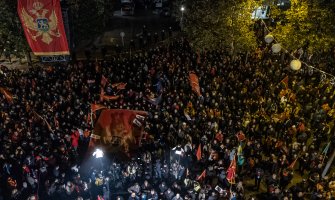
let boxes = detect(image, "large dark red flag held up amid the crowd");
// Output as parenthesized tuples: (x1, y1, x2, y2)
(93, 109, 148, 152)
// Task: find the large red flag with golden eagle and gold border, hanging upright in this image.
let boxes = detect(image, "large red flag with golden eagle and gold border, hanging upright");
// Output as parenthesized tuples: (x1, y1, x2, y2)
(17, 0, 70, 56)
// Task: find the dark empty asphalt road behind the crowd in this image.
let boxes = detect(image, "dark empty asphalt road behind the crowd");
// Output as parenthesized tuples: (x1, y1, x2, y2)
(77, 8, 179, 59)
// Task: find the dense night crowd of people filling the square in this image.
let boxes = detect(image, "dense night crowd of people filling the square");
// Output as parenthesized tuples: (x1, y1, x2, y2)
(0, 40, 335, 200)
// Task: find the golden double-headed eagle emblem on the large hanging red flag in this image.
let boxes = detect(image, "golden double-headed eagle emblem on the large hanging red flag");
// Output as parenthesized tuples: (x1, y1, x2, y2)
(21, 1, 61, 44)
